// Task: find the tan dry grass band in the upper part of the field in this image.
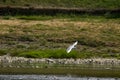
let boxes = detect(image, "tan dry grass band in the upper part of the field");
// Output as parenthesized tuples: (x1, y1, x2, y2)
(0, 19, 120, 41)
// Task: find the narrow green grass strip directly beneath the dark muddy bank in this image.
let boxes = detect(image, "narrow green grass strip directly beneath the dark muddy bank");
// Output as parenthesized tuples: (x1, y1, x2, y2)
(1, 13, 120, 22)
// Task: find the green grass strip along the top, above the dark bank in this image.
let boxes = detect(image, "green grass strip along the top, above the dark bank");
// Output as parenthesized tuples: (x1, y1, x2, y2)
(0, 0, 120, 9)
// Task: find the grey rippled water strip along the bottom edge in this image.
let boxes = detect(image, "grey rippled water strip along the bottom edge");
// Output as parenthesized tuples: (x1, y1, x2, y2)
(0, 75, 120, 80)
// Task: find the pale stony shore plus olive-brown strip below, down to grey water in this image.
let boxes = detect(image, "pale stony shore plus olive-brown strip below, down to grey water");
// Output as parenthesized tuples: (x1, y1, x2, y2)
(0, 56, 120, 77)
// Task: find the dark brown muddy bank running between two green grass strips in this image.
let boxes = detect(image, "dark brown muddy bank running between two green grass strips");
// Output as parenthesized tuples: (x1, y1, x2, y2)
(0, 6, 120, 17)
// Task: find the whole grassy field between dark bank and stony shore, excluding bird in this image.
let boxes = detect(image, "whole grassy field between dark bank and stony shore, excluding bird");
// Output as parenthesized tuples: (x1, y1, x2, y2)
(0, 14, 120, 58)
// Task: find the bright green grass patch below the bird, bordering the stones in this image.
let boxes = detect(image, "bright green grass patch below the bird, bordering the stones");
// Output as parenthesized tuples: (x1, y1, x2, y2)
(19, 49, 78, 58)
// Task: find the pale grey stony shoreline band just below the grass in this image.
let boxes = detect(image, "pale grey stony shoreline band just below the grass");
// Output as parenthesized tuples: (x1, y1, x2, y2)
(0, 55, 120, 65)
